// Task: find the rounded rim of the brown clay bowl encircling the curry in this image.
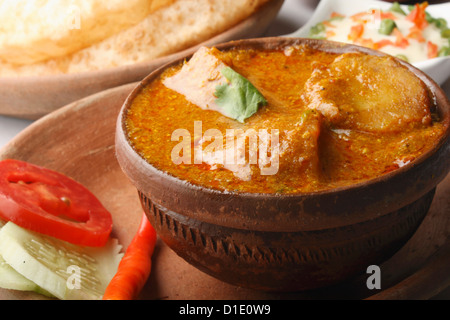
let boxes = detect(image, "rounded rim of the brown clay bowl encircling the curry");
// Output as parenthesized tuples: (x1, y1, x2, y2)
(116, 37, 450, 229)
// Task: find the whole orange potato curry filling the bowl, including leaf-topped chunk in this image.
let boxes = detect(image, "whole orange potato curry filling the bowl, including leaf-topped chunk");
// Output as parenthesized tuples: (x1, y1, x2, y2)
(126, 45, 447, 193)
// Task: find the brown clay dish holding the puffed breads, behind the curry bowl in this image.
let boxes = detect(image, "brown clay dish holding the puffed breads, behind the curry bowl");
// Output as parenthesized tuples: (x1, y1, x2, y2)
(0, 0, 284, 120)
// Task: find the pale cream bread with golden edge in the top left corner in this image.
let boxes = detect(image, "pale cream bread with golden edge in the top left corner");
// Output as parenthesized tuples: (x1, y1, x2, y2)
(0, 0, 172, 65)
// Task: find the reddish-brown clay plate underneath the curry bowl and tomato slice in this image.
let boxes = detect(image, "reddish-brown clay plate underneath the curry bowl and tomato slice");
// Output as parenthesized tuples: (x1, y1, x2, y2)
(0, 84, 450, 300)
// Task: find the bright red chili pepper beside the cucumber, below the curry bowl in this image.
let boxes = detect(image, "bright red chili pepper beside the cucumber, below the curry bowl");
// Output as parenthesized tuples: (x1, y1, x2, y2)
(103, 213, 157, 300)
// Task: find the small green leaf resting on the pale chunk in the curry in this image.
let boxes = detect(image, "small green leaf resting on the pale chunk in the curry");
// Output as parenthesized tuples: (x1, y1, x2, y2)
(214, 67, 267, 123)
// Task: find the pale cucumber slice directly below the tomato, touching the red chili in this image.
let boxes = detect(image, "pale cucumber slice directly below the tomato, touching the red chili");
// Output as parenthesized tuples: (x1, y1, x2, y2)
(0, 222, 123, 300)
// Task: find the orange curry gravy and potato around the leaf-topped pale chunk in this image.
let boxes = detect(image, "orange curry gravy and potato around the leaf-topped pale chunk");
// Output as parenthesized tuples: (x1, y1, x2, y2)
(126, 46, 446, 193)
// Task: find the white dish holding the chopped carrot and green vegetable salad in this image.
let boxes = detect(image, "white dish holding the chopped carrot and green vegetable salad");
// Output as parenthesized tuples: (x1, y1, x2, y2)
(285, 0, 450, 85)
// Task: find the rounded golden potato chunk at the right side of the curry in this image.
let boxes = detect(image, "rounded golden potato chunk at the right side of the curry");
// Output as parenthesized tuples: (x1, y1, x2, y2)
(302, 53, 431, 132)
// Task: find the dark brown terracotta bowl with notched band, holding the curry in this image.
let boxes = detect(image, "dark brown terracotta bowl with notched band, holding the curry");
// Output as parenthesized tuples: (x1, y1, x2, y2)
(116, 38, 450, 291)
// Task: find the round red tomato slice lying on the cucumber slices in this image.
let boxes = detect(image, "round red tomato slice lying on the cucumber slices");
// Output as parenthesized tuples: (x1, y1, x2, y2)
(0, 159, 112, 247)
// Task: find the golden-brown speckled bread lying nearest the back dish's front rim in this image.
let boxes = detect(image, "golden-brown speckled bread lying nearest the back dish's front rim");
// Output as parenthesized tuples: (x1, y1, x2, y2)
(0, 0, 268, 76)
